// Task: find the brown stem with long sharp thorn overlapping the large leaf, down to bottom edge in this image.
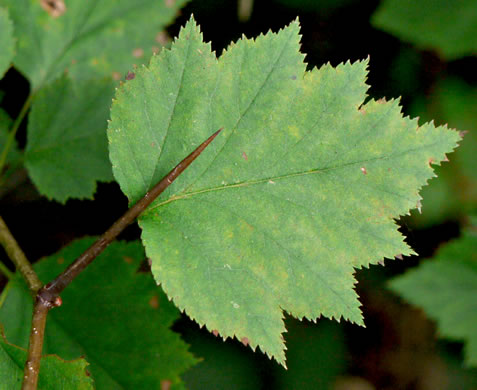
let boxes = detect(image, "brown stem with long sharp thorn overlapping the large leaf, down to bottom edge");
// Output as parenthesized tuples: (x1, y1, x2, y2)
(22, 129, 222, 390)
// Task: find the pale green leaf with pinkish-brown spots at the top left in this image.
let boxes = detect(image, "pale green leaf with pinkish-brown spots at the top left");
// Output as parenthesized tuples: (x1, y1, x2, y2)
(3, 0, 189, 90)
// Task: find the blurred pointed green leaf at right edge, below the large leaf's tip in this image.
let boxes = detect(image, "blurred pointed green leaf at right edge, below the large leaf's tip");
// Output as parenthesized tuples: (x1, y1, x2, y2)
(390, 226, 477, 366)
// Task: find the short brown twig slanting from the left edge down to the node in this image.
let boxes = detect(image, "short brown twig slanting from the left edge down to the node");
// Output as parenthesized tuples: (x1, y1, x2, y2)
(0, 217, 43, 296)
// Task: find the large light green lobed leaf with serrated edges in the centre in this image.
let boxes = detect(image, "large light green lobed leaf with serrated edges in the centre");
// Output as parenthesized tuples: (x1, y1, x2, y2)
(108, 17, 460, 364)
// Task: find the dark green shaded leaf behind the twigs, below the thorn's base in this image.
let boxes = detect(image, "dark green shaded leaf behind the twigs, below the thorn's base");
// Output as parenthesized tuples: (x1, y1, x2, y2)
(0, 239, 196, 390)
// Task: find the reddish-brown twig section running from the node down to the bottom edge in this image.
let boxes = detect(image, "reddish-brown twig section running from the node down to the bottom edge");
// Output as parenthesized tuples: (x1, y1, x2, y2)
(22, 297, 51, 390)
